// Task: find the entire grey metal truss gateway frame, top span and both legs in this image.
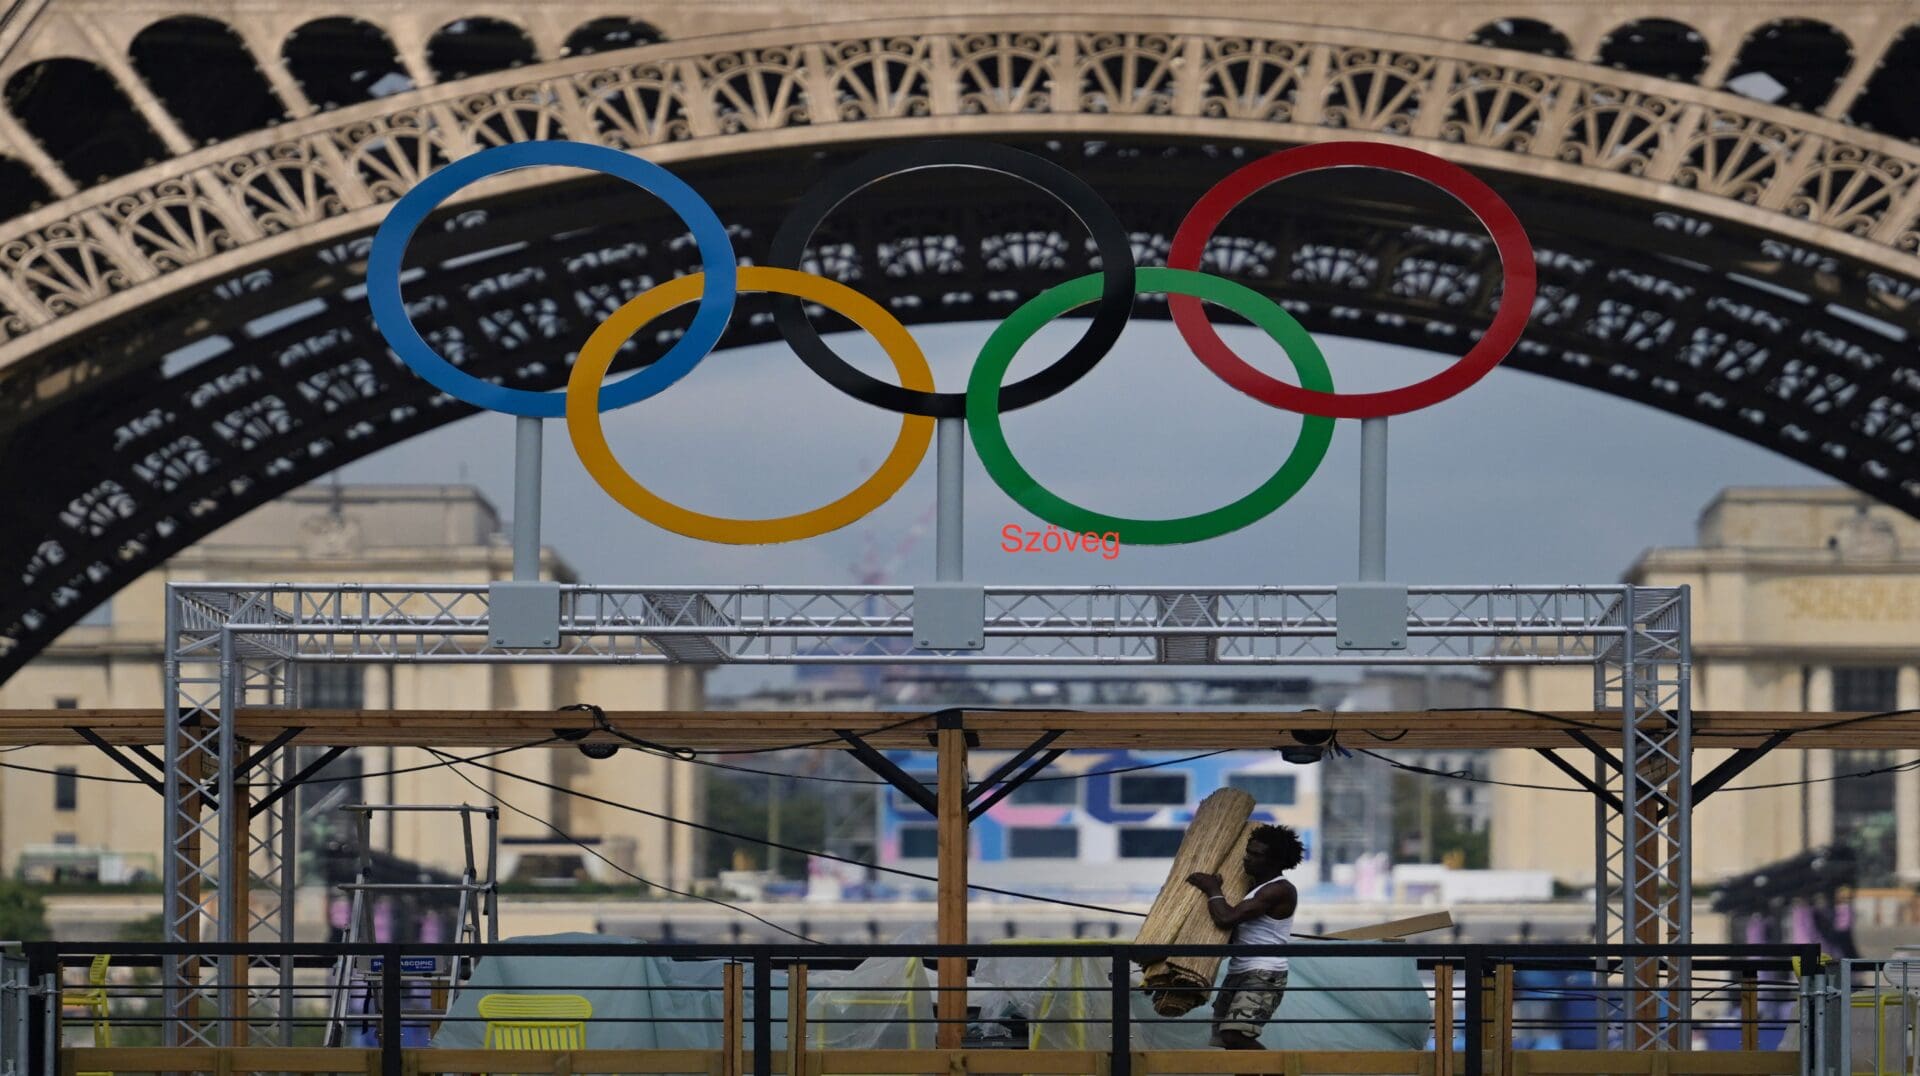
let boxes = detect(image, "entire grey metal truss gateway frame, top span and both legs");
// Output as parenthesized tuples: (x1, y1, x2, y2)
(165, 584, 1692, 1045)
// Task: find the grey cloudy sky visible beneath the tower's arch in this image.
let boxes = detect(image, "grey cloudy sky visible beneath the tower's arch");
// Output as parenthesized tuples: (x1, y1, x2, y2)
(344, 321, 1828, 684)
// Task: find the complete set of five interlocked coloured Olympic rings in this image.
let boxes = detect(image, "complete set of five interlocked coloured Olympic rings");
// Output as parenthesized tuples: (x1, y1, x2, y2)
(367, 142, 1536, 546)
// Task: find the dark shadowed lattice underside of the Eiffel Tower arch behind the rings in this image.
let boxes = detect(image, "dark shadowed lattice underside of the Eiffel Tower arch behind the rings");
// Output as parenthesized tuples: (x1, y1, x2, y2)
(0, 140, 1920, 676)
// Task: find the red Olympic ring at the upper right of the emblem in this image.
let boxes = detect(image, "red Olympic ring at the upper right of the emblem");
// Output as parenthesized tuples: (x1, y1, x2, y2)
(1167, 142, 1536, 419)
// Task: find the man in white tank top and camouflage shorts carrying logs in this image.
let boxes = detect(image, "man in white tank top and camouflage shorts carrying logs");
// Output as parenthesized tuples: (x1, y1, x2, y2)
(1187, 826, 1306, 1049)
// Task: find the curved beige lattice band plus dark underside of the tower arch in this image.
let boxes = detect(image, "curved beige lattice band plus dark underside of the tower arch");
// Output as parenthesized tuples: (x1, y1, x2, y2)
(0, 13, 1920, 676)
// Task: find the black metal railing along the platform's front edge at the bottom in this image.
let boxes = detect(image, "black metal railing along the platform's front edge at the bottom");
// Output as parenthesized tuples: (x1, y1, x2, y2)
(8, 942, 1845, 1076)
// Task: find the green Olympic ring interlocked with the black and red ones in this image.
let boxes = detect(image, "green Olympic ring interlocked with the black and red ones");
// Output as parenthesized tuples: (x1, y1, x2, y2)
(966, 267, 1334, 546)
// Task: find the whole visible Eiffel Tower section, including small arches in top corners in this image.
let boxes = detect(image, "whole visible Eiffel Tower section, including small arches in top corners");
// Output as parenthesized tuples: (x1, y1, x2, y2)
(0, 0, 1920, 676)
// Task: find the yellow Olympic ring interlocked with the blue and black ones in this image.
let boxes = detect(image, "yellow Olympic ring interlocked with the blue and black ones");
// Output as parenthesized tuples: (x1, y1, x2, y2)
(566, 265, 933, 546)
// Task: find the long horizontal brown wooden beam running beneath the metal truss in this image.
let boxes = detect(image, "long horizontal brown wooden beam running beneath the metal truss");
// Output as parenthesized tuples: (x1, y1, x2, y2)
(0, 709, 1920, 751)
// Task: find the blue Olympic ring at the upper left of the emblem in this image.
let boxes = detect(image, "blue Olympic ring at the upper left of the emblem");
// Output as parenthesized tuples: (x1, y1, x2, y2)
(367, 142, 739, 419)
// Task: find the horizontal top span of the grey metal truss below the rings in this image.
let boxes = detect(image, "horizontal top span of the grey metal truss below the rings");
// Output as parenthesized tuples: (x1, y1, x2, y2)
(191, 584, 1635, 665)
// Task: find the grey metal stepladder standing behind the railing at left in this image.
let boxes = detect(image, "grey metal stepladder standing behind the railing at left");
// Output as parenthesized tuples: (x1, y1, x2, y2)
(326, 803, 499, 1045)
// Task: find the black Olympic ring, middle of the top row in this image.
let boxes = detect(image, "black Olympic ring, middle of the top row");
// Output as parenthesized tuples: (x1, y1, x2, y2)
(768, 140, 1135, 419)
